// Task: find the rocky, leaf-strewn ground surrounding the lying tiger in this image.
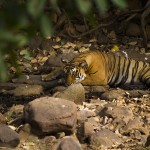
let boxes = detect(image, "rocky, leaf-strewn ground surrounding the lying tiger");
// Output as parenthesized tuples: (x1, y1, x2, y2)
(0, 32, 150, 150)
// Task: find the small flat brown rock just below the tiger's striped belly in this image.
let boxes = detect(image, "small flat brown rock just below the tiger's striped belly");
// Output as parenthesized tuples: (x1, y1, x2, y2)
(101, 90, 125, 101)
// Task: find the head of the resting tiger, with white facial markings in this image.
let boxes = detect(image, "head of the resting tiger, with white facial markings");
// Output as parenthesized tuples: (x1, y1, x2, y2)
(64, 61, 87, 85)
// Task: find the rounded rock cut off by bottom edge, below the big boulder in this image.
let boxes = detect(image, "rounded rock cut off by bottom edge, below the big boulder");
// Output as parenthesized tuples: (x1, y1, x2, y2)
(57, 136, 82, 150)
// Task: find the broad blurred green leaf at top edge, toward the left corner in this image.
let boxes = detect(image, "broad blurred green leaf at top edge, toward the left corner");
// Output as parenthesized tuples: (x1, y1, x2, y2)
(27, 0, 45, 18)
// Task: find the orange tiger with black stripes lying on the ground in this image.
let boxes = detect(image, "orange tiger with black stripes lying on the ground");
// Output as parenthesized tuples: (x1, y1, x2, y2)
(64, 51, 150, 87)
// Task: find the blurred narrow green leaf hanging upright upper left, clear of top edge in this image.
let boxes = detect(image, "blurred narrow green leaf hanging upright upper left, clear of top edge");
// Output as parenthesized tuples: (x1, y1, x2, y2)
(41, 15, 52, 37)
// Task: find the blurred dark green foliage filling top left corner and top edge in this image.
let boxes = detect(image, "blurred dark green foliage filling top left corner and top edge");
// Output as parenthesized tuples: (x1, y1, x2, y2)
(0, 0, 126, 80)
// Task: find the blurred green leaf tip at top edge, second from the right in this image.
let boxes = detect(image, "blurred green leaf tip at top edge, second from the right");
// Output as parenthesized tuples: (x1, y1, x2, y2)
(95, 0, 108, 13)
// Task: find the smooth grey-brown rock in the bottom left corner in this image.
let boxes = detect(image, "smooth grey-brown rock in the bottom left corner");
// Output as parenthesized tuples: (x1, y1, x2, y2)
(0, 124, 20, 147)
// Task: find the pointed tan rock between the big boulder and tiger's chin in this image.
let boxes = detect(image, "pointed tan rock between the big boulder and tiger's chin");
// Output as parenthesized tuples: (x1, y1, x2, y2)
(53, 83, 85, 104)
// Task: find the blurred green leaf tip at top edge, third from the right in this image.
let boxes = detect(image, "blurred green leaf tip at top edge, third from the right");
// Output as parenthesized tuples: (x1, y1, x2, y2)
(76, 0, 91, 14)
